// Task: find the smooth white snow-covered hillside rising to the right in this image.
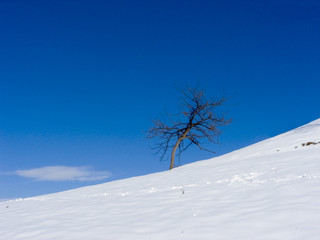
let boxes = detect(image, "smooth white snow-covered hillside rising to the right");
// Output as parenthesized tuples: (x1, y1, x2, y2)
(0, 119, 320, 240)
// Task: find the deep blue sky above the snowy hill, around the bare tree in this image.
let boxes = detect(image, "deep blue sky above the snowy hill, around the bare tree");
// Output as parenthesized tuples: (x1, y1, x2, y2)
(0, 0, 320, 199)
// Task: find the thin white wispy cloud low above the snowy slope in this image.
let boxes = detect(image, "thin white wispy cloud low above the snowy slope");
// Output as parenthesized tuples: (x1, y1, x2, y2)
(13, 166, 111, 181)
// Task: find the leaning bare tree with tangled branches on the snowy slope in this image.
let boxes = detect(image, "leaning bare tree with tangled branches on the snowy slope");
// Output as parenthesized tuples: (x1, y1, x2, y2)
(147, 88, 230, 170)
